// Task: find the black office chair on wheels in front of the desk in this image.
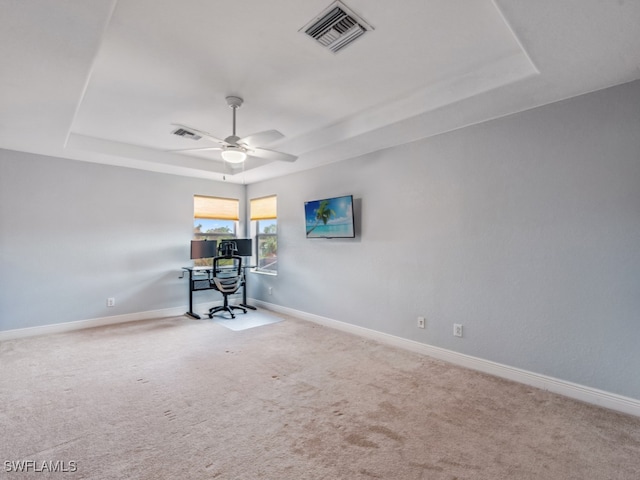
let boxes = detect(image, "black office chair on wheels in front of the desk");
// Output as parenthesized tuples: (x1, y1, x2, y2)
(209, 241, 247, 318)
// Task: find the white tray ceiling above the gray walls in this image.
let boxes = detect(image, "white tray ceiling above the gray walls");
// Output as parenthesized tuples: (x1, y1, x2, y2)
(0, 0, 640, 183)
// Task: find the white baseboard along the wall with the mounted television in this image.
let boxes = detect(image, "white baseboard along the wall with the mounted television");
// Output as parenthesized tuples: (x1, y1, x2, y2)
(253, 300, 640, 417)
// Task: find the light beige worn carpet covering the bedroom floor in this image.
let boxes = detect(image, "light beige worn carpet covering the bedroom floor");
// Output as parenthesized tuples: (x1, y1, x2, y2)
(0, 317, 640, 480)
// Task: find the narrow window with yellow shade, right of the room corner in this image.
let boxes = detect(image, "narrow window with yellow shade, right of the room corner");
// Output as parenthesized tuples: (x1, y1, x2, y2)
(250, 195, 278, 273)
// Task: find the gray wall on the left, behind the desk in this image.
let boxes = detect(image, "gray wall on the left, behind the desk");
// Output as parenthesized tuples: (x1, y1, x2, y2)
(0, 150, 245, 330)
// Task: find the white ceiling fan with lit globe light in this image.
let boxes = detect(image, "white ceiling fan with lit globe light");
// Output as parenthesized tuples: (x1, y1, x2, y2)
(172, 96, 298, 166)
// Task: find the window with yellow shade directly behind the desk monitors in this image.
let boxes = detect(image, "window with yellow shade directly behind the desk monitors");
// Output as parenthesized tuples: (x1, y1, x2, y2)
(193, 195, 240, 265)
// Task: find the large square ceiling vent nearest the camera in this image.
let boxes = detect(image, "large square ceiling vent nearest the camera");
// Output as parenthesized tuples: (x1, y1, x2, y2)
(299, 1, 373, 53)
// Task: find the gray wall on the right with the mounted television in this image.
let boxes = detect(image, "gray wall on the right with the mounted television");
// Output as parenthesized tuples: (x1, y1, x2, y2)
(247, 82, 640, 399)
